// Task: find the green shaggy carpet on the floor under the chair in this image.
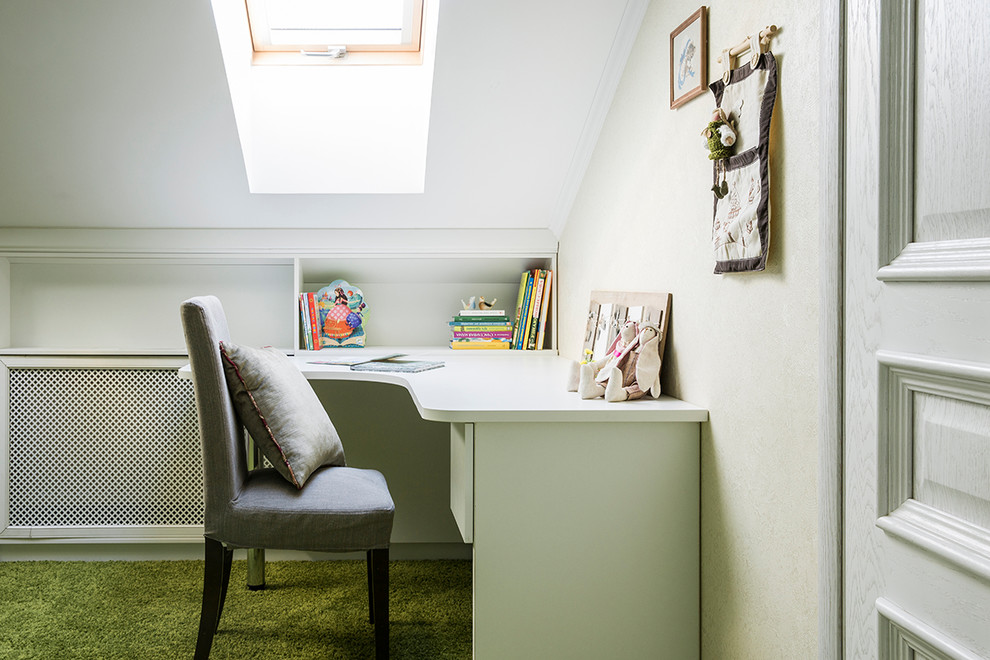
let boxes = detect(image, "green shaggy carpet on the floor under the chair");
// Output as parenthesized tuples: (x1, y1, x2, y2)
(0, 561, 471, 660)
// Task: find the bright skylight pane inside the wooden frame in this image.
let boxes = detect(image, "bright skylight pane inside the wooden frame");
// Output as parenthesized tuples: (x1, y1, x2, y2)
(247, 0, 423, 60)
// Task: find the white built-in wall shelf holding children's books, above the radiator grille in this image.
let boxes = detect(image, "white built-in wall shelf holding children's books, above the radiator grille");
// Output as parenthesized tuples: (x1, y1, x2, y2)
(0, 228, 557, 355)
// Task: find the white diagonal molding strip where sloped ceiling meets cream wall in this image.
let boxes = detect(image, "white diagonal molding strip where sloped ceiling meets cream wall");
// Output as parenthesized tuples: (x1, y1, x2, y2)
(550, 0, 650, 238)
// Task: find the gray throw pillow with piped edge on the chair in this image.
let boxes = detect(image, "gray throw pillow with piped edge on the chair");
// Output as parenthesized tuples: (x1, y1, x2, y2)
(220, 342, 346, 488)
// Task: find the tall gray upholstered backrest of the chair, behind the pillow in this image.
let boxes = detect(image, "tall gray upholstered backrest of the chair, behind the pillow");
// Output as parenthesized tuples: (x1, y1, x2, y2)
(181, 296, 247, 536)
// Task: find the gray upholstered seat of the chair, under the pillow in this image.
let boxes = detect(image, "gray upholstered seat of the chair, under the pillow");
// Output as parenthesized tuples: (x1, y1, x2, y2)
(213, 467, 395, 552)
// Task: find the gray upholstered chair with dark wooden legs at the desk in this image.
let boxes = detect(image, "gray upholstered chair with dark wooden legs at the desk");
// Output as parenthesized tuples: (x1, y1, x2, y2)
(181, 296, 395, 658)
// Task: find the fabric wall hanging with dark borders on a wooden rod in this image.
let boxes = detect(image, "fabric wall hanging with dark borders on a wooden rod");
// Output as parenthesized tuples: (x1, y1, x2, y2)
(709, 26, 777, 273)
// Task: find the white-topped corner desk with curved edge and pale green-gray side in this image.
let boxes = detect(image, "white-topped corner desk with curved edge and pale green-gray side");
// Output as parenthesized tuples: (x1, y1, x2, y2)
(192, 347, 708, 660)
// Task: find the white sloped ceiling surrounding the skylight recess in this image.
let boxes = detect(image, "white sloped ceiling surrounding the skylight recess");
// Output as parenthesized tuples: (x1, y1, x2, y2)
(0, 0, 627, 232)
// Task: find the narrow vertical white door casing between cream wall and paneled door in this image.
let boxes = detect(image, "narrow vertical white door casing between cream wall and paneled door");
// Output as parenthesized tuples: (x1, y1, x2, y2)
(818, 0, 846, 660)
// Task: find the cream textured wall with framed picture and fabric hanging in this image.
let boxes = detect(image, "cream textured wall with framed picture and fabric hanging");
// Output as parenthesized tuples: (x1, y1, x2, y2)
(559, 0, 819, 659)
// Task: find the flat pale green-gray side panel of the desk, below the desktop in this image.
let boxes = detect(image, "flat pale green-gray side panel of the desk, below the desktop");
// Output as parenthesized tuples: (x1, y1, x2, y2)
(474, 423, 700, 659)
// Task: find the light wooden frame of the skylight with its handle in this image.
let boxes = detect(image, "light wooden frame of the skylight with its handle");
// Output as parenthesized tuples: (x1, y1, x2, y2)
(244, 0, 424, 64)
